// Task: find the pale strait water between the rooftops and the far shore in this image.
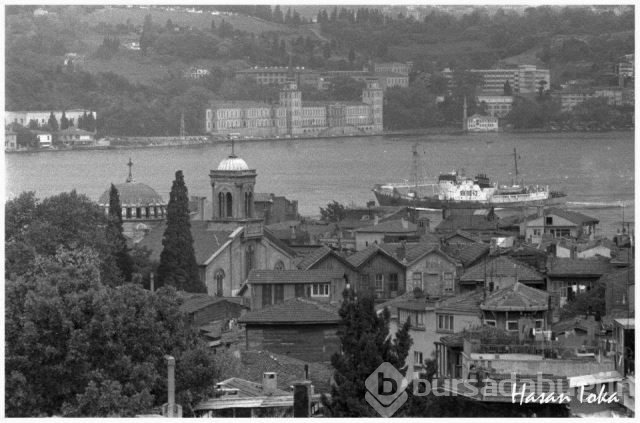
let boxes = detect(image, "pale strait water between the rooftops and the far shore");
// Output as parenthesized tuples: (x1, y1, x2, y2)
(5, 132, 634, 240)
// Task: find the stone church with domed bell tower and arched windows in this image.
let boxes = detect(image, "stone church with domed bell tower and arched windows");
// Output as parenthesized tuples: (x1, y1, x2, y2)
(137, 147, 295, 297)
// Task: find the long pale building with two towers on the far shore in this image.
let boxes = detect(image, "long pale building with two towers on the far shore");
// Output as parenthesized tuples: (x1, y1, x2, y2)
(205, 80, 383, 137)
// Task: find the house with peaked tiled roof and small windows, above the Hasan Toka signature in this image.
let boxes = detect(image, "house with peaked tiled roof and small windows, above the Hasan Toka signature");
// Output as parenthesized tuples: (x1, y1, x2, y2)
(480, 282, 549, 336)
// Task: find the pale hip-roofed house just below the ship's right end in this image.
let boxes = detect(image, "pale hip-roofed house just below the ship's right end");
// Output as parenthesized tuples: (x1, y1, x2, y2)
(520, 208, 600, 244)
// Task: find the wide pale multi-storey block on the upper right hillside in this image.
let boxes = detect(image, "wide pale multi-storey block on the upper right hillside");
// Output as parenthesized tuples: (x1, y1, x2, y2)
(442, 65, 551, 94)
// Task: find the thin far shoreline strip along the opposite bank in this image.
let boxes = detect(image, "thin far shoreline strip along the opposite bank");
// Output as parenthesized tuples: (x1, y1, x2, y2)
(5, 127, 635, 154)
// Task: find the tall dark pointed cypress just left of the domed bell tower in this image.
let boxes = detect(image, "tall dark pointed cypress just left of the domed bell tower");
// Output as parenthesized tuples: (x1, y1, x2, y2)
(158, 170, 207, 292)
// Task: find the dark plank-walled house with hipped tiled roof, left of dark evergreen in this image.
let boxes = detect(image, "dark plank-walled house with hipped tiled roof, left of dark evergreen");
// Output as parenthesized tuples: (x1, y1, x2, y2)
(238, 298, 341, 361)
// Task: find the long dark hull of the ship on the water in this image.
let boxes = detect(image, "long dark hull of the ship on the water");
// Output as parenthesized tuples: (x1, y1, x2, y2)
(373, 189, 566, 209)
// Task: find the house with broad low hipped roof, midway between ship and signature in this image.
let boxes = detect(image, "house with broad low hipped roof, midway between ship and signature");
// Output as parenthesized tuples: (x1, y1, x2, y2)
(460, 255, 546, 292)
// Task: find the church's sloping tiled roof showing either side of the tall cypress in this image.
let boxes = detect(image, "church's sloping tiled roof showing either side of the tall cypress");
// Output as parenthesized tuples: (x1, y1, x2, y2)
(137, 220, 231, 266)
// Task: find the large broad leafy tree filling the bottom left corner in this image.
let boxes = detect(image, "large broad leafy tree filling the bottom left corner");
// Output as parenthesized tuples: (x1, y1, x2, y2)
(5, 248, 226, 417)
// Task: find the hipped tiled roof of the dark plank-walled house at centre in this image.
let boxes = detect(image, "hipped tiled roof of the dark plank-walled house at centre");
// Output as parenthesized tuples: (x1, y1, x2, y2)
(238, 298, 341, 325)
